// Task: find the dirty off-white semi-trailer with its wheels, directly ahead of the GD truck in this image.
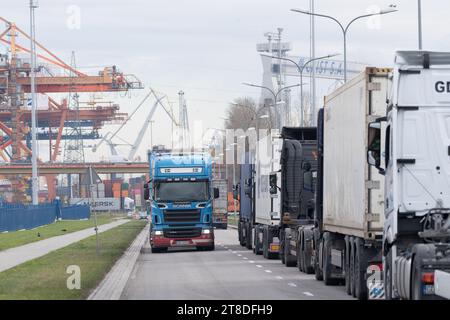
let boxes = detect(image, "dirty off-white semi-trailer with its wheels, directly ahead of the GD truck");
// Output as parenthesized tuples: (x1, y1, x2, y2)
(312, 68, 390, 299)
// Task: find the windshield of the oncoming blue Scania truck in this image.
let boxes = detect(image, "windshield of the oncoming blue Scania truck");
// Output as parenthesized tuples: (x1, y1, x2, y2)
(155, 181, 209, 202)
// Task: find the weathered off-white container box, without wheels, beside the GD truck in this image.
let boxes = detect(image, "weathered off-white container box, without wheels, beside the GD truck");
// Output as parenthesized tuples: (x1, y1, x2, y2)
(323, 68, 389, 239)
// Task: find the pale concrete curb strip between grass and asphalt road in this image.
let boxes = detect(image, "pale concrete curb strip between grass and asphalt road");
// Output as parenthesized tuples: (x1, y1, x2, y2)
(88, 224, 149, 300)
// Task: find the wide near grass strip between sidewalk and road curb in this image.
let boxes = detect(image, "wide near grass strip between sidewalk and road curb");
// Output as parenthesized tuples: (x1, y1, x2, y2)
(0, 220, 146, 300)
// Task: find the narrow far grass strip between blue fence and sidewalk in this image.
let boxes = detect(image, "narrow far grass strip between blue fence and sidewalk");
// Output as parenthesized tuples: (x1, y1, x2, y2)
(0, 214, 121, 251)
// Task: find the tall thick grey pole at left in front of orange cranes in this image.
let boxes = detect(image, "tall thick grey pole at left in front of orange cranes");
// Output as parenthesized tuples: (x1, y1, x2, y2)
(30, 0, 39, 205)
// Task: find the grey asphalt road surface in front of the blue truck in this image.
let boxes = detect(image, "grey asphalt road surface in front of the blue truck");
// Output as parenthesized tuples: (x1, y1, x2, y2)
(121, 229, 352, 300)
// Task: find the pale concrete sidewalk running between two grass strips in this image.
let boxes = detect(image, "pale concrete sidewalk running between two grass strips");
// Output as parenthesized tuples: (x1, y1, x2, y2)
(0, 219, 129, 272)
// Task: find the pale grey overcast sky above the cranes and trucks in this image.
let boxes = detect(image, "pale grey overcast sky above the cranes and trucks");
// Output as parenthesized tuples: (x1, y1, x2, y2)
(1, 0, 450, 160)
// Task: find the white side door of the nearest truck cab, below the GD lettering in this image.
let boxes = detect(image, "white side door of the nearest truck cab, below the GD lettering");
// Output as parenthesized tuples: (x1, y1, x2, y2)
(394, 107, 450, 213)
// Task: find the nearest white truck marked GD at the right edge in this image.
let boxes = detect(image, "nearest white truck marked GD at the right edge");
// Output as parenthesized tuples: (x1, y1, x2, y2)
(367, 51, 450, 299)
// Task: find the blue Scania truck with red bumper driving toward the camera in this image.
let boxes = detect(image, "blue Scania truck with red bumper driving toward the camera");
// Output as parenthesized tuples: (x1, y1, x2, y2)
(144, 152, 219, 253)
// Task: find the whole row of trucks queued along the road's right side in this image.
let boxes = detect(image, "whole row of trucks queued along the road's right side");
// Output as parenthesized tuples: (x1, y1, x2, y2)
(238, 51, 450, 299)
